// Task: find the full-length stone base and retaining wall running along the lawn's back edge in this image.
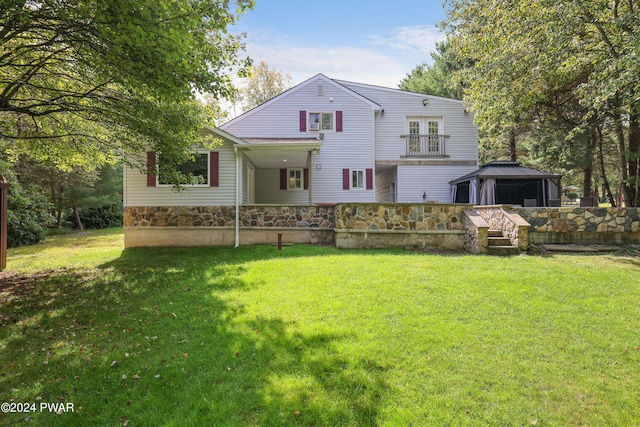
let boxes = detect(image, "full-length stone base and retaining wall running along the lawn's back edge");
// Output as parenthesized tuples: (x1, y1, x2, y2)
(124, 203, 640, 253)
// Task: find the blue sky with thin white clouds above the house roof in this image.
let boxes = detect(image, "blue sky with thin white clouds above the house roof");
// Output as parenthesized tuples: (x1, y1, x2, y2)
(233, 0, 445, 87)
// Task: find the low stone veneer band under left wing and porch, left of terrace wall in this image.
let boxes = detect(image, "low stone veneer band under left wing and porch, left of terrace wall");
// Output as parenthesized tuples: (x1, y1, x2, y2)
(124, 205, 335, 229)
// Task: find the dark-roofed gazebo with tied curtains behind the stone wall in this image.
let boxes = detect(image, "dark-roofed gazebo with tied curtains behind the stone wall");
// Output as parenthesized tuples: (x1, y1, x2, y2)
(449, 161, 562, 206)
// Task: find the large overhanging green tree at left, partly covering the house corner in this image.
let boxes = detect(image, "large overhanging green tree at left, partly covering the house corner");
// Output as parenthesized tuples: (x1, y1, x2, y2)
(0, 0, 253, 174)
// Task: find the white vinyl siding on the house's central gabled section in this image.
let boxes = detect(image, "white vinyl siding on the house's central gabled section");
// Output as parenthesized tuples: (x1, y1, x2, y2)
(221, 76, 378, 203)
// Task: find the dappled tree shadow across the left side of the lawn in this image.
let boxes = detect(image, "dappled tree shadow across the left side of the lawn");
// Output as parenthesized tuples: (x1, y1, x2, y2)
(0, 248, 386, 426)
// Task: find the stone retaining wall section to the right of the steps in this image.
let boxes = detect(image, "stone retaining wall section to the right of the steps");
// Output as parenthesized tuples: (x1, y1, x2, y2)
(514, 207, 640, 244)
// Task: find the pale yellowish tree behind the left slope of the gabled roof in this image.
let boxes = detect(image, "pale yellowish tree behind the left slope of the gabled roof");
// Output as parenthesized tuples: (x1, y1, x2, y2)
(240, 61, 292, 110)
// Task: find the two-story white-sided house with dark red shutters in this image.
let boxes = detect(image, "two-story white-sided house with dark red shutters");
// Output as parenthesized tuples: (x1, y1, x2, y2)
(124, 74, 478, 247)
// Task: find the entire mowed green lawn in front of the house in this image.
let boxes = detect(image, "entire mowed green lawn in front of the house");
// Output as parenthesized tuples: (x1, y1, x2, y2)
(0, 230, 640, 426)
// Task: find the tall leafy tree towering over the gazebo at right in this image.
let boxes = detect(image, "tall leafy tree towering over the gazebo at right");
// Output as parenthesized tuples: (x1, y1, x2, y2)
(446, 0, 640, 206)
